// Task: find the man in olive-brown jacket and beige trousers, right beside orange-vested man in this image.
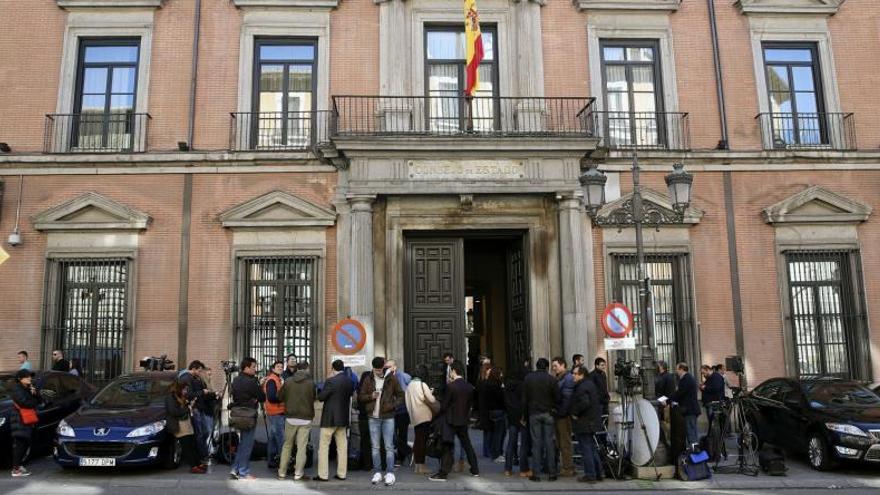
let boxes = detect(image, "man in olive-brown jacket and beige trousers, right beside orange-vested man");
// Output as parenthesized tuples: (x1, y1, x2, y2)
(278, 361, 316, 481)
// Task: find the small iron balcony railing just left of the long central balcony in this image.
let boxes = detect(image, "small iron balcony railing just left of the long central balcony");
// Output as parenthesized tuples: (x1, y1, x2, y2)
(229, 110, 332, 151)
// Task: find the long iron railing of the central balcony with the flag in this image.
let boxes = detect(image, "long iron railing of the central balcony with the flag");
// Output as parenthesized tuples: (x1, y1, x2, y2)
(333, 96, 593, 137)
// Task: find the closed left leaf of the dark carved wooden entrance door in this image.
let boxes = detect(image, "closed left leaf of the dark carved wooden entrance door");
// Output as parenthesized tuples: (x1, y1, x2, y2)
(404, 238, 465, 386)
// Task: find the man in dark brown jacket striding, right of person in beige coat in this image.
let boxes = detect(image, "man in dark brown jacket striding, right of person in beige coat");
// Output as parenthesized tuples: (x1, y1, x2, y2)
(428, 361, 480, 481)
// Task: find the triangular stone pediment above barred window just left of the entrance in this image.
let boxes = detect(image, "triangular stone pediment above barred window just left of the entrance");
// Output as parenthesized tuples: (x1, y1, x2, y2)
(220, 191, 336, 228)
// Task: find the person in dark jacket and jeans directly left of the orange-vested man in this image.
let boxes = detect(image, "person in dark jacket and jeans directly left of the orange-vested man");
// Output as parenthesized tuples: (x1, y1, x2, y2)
(229, 357, 266, 481)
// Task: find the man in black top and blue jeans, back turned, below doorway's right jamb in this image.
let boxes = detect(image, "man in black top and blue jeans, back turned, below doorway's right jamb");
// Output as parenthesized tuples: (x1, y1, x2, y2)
(523, 358, 562, 481)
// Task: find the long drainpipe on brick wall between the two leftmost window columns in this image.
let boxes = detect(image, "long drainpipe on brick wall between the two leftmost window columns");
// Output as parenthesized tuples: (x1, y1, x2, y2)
(177, 0, 202, 368)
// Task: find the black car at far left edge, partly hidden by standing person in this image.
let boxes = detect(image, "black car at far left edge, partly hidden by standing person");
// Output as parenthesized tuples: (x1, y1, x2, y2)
(0, 371, 95, 467)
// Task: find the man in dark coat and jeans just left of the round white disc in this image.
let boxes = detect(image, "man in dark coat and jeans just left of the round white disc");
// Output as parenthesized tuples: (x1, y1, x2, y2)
(571, 366, 604, 483)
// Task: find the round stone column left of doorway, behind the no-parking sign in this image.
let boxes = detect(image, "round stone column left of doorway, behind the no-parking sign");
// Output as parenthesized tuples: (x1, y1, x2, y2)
(348, 195, 376, 363)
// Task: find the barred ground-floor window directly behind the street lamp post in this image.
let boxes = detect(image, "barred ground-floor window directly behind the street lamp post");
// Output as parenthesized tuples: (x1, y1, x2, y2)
(612, 254, 694, 365)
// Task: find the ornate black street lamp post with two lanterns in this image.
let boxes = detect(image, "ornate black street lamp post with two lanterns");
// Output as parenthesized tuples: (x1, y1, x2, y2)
(580, 154, 694, 400)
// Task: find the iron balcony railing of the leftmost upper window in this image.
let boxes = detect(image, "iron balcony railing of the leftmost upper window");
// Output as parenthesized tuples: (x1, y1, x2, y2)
(43, 112, 151, 153)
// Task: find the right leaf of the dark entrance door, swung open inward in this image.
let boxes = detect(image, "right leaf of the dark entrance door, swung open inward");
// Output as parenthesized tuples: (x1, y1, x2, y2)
(507, 237, 532, 368)
